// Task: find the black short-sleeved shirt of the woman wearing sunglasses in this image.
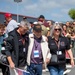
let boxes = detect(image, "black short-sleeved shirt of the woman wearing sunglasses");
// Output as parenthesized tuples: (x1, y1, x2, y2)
(48, 36, 70, 67)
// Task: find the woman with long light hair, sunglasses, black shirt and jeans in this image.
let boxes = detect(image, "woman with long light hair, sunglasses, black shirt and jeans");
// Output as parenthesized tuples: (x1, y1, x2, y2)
(48, 23, 74, 75)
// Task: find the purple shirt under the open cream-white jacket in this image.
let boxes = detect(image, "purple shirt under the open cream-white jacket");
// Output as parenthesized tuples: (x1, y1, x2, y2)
(31, 37, 43, 64)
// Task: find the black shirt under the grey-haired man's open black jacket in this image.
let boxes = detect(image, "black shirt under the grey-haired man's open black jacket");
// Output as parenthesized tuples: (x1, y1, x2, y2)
(16, 31, 26, 67)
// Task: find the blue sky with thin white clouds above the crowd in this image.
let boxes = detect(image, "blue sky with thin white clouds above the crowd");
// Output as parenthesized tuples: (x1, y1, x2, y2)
(0, 0, 75, 22)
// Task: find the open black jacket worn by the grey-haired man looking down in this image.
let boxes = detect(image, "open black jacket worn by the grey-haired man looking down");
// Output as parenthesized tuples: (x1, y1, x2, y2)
(5, 29, 29, 67)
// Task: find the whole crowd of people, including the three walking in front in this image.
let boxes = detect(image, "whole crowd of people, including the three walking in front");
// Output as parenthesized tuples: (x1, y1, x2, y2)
(0, 13, 75, 75)
